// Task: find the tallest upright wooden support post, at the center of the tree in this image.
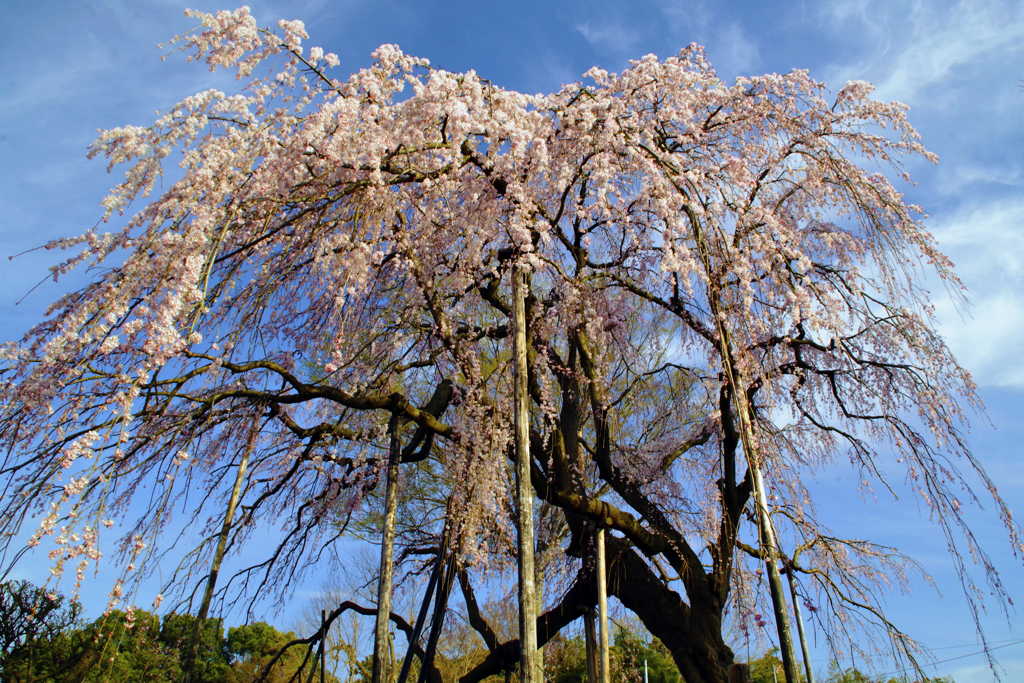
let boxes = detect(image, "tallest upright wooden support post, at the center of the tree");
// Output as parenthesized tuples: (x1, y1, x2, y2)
(512, 265, 544, 683)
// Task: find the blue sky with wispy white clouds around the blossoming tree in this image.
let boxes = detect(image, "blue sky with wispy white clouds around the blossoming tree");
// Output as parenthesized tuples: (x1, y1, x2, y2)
(0, 0, 1024, 683)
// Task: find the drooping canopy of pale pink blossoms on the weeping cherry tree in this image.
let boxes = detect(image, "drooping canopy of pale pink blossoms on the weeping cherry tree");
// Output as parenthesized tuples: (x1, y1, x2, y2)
(0, 8, 1019, 676)
